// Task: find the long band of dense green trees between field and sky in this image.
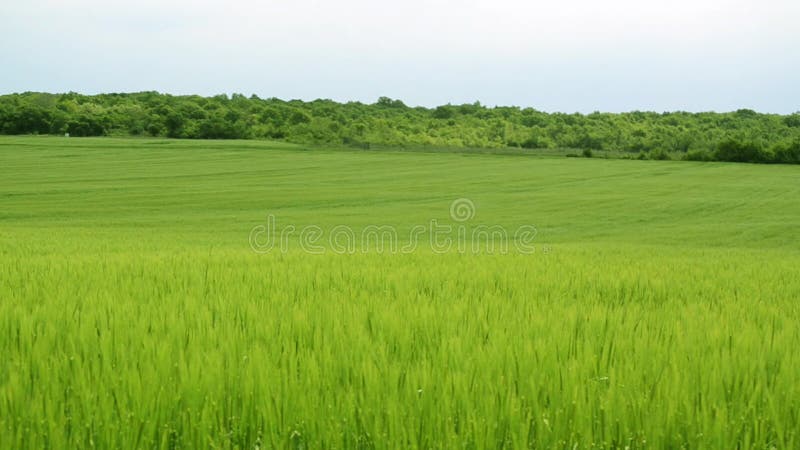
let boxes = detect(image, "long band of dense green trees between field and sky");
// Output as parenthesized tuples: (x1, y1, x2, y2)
(0, 92, 800, 164)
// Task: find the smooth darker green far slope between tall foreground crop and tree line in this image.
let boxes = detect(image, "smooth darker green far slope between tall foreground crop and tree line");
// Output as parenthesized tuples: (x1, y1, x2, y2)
(0, 138, 800, 248)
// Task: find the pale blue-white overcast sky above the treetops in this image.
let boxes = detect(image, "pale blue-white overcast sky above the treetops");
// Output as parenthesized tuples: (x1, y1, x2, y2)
(0, 0, 800, 113)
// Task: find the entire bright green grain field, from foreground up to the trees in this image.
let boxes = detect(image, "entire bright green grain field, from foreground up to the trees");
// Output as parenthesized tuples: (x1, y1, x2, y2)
(0, 137, 800, 449)
